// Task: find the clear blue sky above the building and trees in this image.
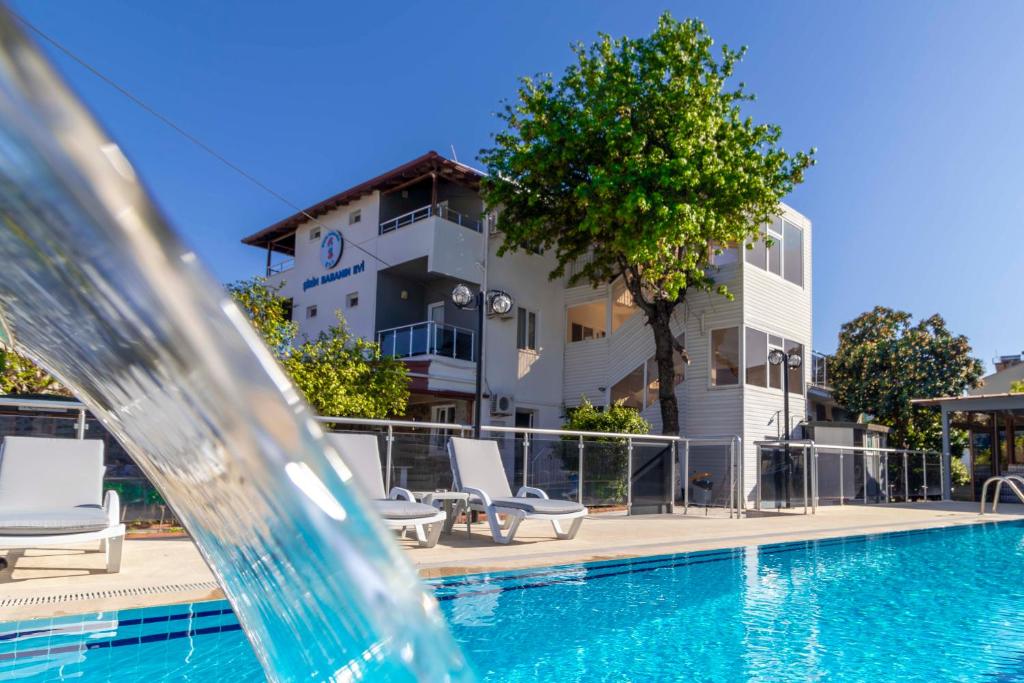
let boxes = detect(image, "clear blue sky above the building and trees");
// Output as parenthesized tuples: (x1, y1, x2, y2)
(13, 0, 1024, 370)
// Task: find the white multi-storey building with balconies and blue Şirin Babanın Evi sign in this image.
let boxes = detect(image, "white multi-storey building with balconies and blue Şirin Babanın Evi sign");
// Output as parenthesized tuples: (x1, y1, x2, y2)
(243, 152, 811, 501)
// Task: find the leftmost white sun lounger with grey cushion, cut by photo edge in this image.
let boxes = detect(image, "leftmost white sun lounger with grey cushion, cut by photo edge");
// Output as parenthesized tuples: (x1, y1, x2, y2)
(0, 436, 125, 573)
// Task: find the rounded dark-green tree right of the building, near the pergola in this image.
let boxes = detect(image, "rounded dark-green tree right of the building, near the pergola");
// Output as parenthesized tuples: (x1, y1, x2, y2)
(828, 306, 983, 451)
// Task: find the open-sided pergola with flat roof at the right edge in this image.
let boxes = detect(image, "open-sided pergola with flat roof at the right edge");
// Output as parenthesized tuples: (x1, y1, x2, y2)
(911, 392, 1024, 499)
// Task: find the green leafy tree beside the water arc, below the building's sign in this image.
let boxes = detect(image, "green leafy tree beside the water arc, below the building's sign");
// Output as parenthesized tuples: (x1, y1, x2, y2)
(227, 278, 409, 418)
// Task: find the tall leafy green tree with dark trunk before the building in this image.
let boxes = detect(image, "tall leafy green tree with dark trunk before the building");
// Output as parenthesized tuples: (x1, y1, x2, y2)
(480, 12, 814, 434)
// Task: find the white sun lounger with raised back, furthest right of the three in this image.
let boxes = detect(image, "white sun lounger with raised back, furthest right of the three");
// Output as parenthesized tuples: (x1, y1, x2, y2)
(447, 436, 587, 544)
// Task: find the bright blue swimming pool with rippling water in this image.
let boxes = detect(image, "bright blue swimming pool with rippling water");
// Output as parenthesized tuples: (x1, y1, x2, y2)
(6, 522, 1024, 682)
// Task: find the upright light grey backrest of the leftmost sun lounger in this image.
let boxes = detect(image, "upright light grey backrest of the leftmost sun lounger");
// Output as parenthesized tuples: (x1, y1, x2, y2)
(0, 436, 103, 510)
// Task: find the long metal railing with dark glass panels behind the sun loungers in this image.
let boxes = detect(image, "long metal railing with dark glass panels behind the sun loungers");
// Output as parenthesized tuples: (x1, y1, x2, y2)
(316, 417, 745, 517)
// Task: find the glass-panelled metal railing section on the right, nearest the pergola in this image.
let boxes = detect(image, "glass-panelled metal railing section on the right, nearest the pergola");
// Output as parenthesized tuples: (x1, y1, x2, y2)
(754, 439, 949, 514)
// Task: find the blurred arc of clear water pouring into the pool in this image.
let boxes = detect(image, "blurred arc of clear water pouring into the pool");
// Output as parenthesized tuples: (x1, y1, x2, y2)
(0, 10, 471, 681)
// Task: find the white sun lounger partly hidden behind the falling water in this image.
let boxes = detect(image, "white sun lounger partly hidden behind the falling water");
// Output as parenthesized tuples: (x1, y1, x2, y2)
(327, 432, 445, 548)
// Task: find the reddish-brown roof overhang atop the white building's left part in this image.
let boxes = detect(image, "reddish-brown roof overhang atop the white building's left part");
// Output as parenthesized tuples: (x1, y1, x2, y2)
(242, 151, 484, 254)
